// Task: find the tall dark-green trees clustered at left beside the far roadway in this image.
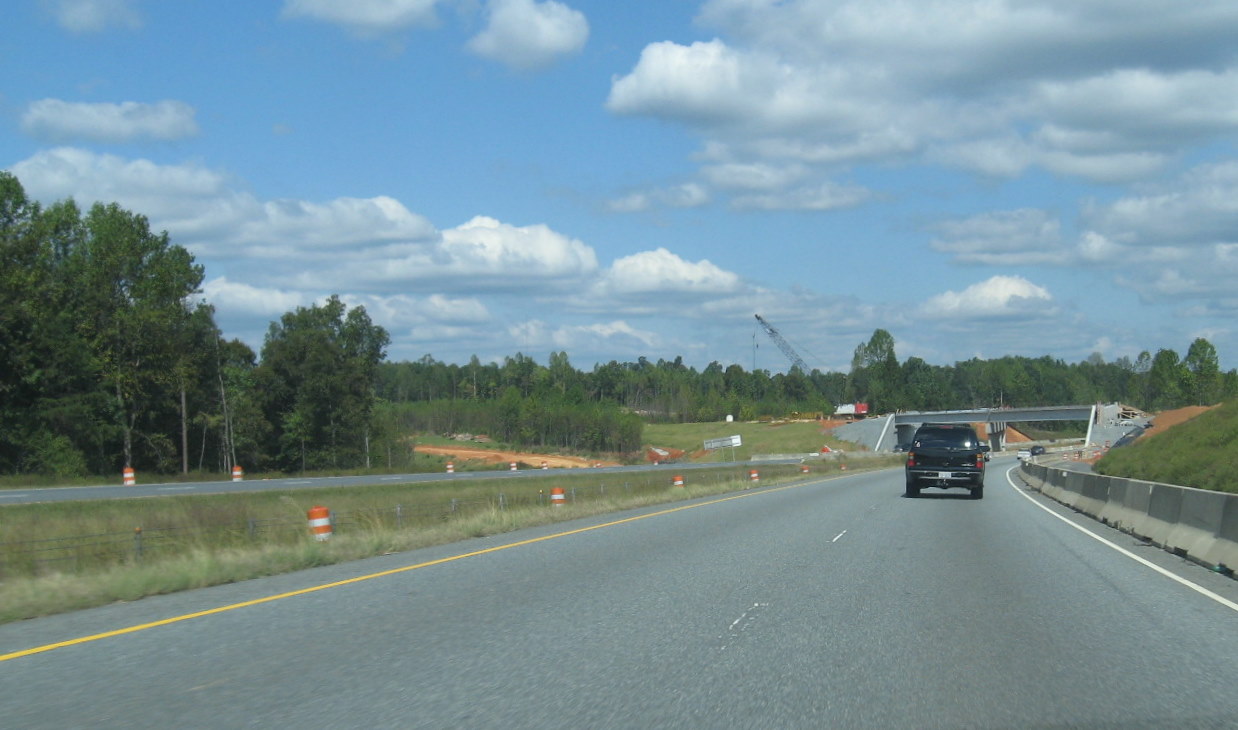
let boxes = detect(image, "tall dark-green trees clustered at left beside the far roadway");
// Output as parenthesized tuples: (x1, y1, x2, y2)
(0, 172, 389, 476)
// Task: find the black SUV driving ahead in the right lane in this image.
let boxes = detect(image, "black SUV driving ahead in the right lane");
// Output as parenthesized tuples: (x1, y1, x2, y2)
(904, 423, 989, 500)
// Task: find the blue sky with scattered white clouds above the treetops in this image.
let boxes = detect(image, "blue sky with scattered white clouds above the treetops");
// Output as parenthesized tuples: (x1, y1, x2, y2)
(7, 0, 1238, 371)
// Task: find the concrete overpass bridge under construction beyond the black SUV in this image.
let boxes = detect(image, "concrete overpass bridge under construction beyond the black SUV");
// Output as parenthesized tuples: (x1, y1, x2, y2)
(834, 403, 1149, 452)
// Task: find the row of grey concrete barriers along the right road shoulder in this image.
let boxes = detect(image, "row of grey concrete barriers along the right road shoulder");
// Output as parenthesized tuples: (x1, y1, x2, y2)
(1020, 464, 1238, 579)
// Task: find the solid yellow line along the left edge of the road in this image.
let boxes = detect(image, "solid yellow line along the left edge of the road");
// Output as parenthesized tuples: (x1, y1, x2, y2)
(0, 480, 820, 662)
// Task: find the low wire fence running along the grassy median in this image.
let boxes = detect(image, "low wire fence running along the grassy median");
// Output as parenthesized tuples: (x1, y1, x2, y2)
(0, 469, 790, 580)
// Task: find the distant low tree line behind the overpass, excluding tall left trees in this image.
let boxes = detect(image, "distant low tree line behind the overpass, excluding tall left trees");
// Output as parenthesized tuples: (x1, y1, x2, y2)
(378, 329, 1238, 423)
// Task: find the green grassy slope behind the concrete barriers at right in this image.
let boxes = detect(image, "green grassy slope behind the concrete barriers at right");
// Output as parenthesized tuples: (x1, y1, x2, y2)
(1094, 401, 1238, 494)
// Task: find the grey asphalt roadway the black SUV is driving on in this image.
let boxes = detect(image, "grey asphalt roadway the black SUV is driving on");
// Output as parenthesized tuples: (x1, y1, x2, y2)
(0, 459, 1238, 730)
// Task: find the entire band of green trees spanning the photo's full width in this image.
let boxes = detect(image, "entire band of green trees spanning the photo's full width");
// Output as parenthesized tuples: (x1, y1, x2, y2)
(0, 172, 1238, 476)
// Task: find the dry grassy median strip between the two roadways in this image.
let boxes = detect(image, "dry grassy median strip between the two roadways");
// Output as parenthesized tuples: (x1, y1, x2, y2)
(0, 458, 898, 622)
